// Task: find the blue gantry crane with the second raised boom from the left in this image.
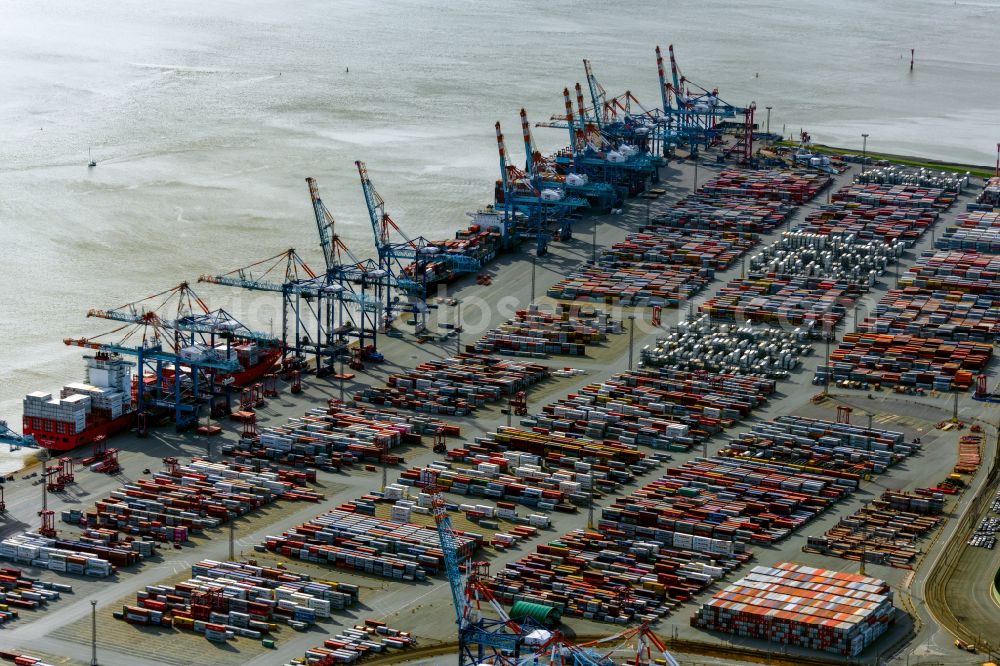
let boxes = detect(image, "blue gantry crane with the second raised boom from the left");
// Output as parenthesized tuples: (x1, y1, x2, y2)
(354, 160, 482, 302)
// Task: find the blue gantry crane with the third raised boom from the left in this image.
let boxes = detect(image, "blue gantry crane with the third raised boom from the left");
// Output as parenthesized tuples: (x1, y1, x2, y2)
(495, 121, 590, 256)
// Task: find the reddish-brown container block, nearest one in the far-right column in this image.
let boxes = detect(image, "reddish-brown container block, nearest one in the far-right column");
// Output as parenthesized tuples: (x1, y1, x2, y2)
(813, 333, 993, 391)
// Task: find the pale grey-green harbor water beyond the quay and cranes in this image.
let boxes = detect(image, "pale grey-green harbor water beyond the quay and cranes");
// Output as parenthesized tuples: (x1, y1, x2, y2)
(0, 0, 1000, 471)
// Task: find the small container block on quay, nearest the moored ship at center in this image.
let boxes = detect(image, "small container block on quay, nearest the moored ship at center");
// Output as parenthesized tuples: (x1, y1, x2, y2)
(472, 305, 622, 358)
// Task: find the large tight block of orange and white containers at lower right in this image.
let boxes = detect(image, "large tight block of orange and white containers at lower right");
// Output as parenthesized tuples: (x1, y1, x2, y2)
(691, 563, 895, 656)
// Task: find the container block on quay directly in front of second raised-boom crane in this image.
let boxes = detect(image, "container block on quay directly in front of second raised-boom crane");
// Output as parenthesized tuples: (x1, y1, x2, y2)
(355, 354, 549, 416)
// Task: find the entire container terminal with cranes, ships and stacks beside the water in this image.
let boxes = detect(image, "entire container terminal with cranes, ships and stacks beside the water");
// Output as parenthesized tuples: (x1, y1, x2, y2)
(0, 47, 1000, 666)
